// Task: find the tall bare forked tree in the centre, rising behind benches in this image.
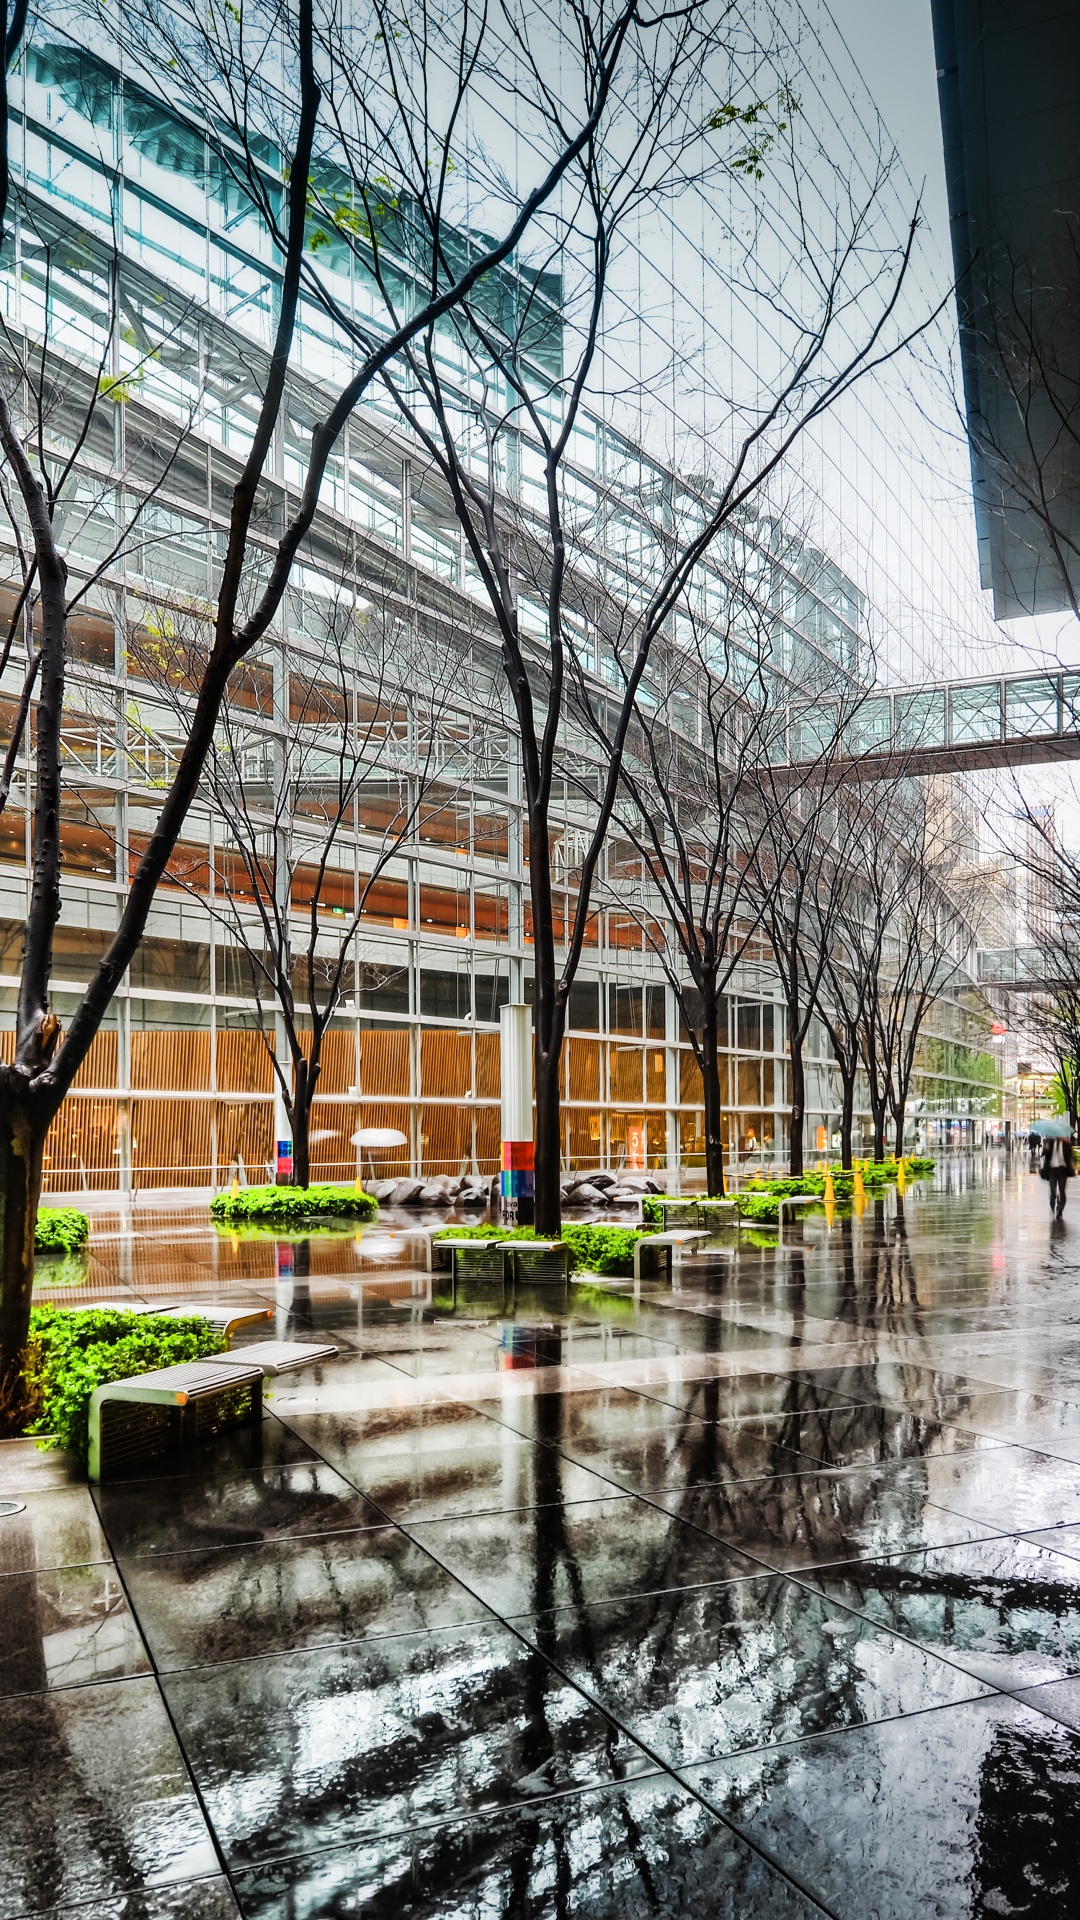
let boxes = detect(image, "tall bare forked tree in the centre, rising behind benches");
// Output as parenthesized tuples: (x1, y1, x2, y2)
(274, 0, 933, 1233)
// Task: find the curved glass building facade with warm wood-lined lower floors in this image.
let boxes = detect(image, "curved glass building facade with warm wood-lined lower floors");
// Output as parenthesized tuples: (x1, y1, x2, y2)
(0, 18, 997, 1188)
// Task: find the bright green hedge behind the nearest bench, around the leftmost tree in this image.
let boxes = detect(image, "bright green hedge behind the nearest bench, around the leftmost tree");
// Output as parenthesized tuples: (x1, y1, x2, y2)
(25, 1308, 225, 1459)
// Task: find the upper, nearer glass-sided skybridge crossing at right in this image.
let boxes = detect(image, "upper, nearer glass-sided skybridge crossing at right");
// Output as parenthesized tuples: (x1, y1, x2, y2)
(773, 670, 1080, 780)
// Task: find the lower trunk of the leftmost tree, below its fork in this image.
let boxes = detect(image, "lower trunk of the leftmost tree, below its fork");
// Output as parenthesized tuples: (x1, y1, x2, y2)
(0, 1069, 52, 1411)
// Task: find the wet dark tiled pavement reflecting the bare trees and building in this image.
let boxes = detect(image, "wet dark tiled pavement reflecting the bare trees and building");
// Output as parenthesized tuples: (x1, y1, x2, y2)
(0, 1160, 1080, 1920)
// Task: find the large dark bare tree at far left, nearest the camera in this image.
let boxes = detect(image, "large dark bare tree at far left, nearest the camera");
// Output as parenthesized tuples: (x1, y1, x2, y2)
(0, 0, 664, 1413)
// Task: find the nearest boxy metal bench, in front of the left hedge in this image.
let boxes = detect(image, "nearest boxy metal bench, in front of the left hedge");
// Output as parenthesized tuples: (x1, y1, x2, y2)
(88, 1354, 263, 1480)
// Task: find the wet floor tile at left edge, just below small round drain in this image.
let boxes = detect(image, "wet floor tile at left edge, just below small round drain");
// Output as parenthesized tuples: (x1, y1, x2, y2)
(0, 1561, 150, 1693)
